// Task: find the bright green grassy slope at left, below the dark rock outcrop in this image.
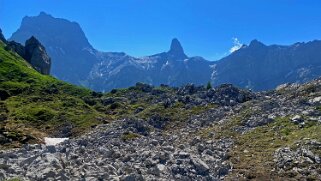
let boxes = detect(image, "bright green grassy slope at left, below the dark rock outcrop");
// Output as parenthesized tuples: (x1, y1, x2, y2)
(0, 42, 103, 148)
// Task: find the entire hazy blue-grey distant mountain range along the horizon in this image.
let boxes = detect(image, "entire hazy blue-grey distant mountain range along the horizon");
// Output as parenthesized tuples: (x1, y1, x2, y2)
(10, 12, 321, 91)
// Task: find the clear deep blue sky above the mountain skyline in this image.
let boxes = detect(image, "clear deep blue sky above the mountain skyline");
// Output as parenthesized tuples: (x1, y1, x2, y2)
(0, 0, 321, 60)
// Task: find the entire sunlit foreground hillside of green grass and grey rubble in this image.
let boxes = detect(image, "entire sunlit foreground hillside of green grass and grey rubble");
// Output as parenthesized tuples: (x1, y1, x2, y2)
(0, 36, 321, 180)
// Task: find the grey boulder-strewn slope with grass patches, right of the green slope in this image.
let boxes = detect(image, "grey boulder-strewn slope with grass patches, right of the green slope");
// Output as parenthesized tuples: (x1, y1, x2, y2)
(0, 79, 321, 180)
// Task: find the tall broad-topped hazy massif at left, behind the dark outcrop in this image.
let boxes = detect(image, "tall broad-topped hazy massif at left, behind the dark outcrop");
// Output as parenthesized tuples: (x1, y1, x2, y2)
(10, 12, 98, 84)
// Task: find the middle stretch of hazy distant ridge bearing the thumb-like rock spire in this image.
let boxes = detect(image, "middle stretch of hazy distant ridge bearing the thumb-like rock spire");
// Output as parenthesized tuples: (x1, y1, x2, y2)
(88, 39, 211, 90)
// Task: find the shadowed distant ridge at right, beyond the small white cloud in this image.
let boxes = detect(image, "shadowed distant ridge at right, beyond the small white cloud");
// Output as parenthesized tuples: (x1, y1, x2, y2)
(212, 40, 321, 90)
